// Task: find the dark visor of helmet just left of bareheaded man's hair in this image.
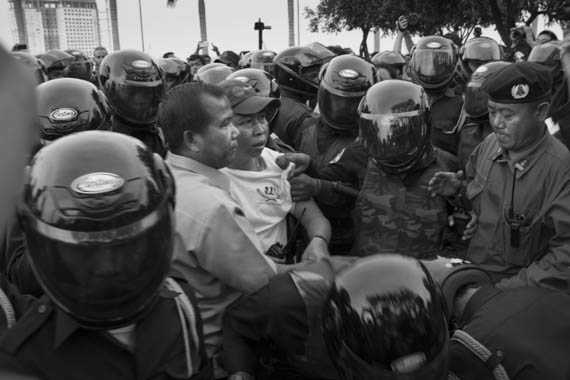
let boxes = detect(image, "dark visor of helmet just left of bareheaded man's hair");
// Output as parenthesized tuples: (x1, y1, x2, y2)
(108, 81, 164, 124)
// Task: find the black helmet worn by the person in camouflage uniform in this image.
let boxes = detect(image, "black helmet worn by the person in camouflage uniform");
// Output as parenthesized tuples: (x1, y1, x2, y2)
(359, 79, 429, 174)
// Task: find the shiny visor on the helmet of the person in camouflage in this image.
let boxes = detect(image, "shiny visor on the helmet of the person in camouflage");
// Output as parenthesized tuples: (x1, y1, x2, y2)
(359, 111, 427, 164)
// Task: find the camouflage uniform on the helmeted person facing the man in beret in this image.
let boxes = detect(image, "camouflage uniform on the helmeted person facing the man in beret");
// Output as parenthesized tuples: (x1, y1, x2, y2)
(352, 148, 456, 256)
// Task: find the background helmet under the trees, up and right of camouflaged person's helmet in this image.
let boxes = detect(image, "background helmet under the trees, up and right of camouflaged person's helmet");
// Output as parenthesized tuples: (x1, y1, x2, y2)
(410, 36, 458, 91)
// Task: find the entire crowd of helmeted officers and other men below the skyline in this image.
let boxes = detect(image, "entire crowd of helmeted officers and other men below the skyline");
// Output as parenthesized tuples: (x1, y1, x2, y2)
(0, 17, 570, 380)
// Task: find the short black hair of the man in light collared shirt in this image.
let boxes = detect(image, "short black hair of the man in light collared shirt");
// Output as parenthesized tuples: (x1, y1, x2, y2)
(158, 82, 229, 153)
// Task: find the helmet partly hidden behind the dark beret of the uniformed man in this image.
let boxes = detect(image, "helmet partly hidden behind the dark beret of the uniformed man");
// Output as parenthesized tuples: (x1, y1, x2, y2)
(463, 61, 509, 118)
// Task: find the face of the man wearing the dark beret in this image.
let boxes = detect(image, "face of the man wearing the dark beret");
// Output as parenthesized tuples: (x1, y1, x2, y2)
(489, 100, 543, 152)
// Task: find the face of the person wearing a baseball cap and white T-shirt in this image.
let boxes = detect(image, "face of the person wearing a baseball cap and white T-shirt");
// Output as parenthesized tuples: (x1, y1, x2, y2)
(232, 111, 269, 157)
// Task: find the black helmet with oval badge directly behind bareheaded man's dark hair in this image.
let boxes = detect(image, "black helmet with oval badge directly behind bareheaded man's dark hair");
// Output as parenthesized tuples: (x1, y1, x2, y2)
(99, 50, 164, 127)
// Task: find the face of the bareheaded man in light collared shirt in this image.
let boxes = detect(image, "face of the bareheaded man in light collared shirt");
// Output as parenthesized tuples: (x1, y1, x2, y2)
(197, 97, 239, 169)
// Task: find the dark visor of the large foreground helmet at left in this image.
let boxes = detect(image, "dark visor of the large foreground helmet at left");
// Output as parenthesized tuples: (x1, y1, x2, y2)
(27, 206, 174, 328)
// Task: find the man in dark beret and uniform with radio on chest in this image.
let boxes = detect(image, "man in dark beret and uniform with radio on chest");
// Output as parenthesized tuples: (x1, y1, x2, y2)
(430, 62, 570, 291)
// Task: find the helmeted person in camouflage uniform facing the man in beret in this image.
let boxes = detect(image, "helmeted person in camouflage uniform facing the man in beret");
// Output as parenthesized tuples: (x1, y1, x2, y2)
(352, 80, 466, 256)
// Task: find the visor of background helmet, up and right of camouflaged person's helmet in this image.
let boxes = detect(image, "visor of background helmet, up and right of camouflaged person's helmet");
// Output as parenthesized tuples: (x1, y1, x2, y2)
(411, 49, 456, 85)
